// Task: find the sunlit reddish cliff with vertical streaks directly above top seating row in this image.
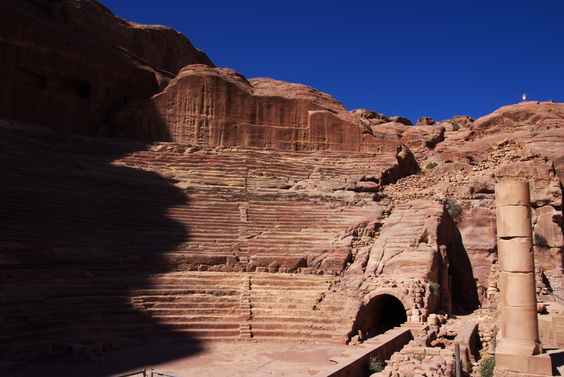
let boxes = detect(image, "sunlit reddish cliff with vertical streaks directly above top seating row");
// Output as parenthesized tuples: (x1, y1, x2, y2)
(114, 65, 399, 152)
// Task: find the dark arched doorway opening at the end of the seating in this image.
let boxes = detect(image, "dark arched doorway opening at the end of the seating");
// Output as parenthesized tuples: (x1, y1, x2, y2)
(353, 294, 407, 337)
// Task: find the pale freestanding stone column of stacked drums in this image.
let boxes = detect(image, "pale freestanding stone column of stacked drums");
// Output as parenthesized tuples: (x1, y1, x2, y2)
(495, 181, 543, 374)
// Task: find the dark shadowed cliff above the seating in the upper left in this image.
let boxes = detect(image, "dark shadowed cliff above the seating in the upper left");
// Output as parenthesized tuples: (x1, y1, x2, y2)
(0, 0, 213, 136)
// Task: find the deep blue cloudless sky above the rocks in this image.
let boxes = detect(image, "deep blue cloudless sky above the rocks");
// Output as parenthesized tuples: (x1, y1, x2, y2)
(101, 0, 564, 122)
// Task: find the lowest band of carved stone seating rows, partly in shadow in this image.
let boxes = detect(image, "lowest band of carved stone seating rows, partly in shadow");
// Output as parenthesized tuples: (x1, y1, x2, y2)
(0, 271, 346, 356)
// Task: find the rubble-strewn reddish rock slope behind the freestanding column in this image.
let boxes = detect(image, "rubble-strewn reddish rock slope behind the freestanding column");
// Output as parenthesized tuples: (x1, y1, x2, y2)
(383, 113, 564, 305)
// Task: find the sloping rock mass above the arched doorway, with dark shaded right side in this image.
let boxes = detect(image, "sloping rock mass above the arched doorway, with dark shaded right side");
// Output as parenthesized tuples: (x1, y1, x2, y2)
(350, 200, 478, 319)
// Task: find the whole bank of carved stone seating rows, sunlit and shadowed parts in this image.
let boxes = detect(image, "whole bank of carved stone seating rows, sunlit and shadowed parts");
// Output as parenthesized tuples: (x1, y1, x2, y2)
(0, 119, 414, 359)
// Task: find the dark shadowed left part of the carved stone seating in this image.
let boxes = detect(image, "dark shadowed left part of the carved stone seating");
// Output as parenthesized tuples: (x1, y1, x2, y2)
(0, 118, 206, 372)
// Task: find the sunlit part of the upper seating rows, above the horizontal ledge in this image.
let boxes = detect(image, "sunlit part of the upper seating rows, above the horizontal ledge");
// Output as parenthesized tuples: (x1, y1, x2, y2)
(114, 143, 397, 273)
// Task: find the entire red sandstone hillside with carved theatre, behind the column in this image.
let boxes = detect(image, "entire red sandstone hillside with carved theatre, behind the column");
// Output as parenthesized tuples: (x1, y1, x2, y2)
(0, 0, 564, 373)
